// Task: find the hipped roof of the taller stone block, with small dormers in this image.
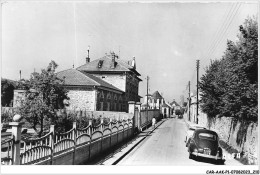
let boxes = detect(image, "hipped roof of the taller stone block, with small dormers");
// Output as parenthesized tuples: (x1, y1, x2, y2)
(77, 55, 140, 76)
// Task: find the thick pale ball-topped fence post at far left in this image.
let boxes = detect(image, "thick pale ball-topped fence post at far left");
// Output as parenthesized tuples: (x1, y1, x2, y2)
(9, 122, 23, 165)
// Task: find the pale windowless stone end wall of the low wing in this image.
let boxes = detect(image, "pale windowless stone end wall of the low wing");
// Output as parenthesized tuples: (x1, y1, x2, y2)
(67, 90, 96, 111)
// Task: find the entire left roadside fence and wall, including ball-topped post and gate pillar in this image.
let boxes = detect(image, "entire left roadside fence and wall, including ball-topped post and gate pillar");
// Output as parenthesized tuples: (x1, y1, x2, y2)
(1, 102, 160, 165)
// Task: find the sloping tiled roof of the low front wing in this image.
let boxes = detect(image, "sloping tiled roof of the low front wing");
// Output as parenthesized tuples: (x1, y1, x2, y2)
(57, 69, 123, 92)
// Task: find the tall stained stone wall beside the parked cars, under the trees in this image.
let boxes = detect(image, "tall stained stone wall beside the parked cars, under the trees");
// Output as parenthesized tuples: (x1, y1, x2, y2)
(198, 112, 259, 164)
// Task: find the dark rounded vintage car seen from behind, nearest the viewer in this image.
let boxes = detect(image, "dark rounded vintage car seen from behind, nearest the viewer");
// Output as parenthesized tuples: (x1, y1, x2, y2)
(188, 129, 225, 162)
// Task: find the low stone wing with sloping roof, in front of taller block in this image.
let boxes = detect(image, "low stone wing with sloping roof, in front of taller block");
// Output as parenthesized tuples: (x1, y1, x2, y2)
(57, 69, 124, 111)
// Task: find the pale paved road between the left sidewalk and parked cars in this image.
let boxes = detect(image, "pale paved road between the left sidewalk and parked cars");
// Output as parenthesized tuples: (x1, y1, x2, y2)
(117, 118, 241, 166)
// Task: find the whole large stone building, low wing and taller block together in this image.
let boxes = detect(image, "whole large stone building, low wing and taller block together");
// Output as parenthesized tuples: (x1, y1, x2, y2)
(11, 52, 142, 112)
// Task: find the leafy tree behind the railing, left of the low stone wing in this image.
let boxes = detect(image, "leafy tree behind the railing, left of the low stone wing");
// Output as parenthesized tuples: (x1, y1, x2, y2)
(18, 61, 68, 136)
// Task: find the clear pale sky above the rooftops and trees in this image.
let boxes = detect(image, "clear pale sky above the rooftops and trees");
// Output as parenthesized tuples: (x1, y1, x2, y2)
(1, 1, 258, 102)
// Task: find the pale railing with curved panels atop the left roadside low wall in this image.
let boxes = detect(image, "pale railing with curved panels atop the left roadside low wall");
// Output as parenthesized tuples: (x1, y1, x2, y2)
(1, 119, 133, 165)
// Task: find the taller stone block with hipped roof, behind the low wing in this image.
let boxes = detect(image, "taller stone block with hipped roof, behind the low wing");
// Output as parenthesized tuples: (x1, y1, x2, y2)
(77, 52, 142, 111)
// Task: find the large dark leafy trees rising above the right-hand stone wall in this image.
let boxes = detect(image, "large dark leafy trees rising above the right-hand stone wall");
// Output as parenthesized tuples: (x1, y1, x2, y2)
(199, 17, 258, 122)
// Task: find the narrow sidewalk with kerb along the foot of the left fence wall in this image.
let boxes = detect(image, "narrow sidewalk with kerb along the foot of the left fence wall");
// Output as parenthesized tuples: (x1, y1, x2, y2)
(101, 119, 167, 165)
